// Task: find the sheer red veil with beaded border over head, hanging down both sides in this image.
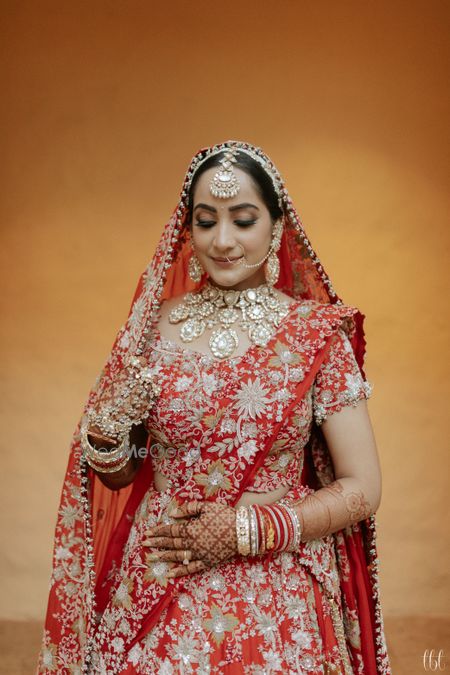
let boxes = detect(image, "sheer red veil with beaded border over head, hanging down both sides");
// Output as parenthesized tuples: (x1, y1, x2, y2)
(38, 141, 390, 675)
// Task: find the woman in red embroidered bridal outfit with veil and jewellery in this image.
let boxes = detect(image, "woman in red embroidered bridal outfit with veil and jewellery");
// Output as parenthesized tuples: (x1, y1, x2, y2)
(39, 141, 391, 675)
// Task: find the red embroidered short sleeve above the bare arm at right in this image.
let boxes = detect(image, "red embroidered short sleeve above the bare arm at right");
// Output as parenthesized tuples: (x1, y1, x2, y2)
(312, 328, 372, 425)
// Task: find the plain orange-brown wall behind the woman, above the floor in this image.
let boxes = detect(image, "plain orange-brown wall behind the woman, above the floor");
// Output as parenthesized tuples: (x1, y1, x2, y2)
(0, 0, 450, 619)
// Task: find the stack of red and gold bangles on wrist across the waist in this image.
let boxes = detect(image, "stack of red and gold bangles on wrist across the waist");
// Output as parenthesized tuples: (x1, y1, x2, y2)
(236, 501, 301, 556)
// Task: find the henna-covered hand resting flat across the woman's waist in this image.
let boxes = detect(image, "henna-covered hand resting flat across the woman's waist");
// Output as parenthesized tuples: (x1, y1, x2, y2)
(142, 501, 238, 577)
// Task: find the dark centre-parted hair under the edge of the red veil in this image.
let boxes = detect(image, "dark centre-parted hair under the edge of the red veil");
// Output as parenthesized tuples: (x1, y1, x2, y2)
(188, 151, 283, 224)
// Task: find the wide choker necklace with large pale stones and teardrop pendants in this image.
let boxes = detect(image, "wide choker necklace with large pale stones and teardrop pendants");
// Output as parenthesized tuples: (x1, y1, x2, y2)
(169, 282, 289, 359)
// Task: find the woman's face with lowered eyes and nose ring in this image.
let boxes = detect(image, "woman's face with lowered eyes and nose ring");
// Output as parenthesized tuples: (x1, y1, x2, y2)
(192, 167, 273, 290)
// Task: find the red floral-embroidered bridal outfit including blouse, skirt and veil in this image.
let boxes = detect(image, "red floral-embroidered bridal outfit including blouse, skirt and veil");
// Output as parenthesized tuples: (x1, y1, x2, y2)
(38, 142, 391, 675)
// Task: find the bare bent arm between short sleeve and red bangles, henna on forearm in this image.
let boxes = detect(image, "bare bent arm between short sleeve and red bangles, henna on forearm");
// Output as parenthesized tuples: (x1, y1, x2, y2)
(295, 399, 381, 541)
